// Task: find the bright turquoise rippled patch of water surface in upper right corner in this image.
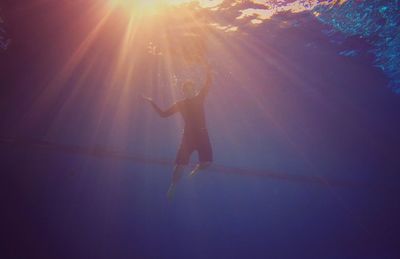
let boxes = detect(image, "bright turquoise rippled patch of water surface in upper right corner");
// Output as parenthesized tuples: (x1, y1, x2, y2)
(314, 0, 400, 93)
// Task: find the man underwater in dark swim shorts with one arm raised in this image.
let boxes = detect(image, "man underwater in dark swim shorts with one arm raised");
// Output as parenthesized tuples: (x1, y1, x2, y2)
(143, 64, 213, 200)
